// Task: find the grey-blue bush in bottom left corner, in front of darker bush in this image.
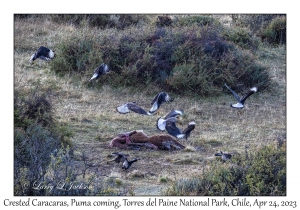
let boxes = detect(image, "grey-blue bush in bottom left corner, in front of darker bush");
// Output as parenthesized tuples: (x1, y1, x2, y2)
(14, 124, 60, 195)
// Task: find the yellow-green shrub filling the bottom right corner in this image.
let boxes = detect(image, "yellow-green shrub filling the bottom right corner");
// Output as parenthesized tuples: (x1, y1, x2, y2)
(164, 145, 286, 196)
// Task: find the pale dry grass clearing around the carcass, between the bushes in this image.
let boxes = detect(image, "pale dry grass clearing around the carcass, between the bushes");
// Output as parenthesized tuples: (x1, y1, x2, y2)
(14, 17, 286, 195)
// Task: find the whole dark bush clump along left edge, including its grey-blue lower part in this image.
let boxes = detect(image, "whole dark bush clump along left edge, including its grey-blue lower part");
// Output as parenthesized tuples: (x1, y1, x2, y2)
(14, 87, 70, 195)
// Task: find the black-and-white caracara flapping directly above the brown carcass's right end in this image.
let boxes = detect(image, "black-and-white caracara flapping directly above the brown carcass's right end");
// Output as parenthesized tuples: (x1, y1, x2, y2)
(156, 117, 196, 140)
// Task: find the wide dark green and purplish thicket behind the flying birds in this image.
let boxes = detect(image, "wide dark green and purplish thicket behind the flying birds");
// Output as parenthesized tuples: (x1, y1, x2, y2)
(51, 16, 270, 95)
